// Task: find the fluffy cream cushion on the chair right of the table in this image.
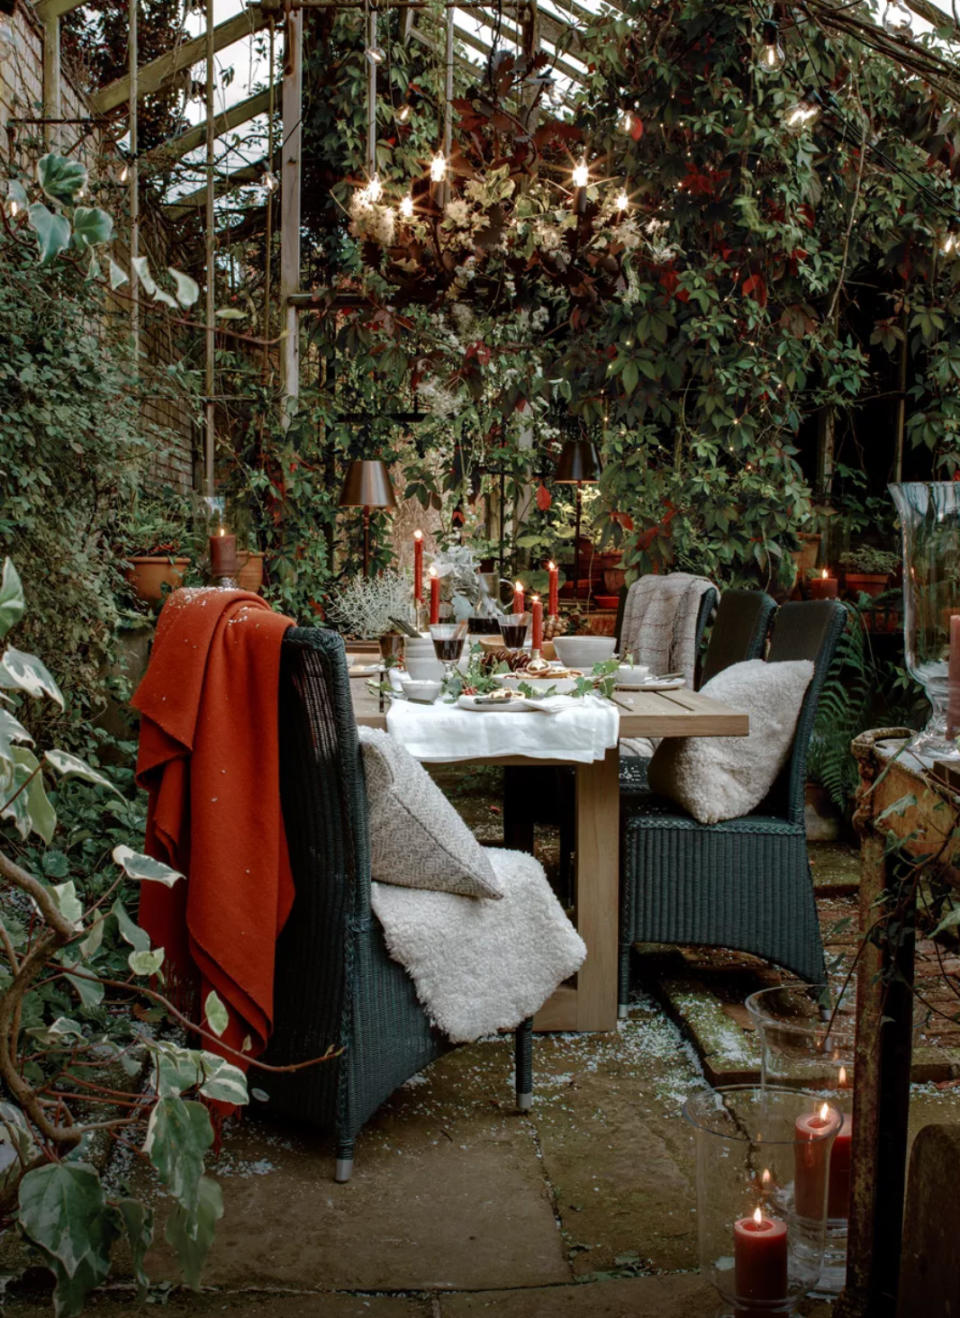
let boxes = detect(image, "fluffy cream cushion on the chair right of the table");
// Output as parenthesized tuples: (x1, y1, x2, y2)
(649, 659, 814, 824)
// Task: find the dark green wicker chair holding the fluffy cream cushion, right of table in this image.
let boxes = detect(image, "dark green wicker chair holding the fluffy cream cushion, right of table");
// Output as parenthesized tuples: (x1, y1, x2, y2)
(618, 600, 847, 1015)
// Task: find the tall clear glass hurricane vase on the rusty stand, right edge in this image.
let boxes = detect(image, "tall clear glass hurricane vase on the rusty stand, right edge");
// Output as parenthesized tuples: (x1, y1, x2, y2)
(889, 481, 960, 759)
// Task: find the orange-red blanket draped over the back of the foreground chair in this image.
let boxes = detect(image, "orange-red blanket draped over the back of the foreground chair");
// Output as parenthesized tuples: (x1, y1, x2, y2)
(133, 589, 293, 1062)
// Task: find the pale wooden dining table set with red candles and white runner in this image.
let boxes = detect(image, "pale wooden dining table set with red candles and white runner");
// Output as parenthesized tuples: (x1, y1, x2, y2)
(351, 677, 749, 1031)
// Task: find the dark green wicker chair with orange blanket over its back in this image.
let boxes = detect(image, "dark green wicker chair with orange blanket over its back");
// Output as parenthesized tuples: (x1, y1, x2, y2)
(262, 627, 533, 1181)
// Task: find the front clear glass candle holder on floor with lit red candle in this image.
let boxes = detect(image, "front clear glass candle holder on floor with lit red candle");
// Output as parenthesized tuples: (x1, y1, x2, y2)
(683, 1085, 840, 1318)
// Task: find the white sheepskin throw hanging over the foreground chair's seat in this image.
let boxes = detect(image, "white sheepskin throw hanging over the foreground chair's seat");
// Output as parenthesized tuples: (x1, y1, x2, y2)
(371, 847, 587, 1044)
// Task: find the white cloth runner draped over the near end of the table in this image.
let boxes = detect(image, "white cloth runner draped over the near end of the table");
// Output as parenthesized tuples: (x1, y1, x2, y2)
(386, 696, 620, 764)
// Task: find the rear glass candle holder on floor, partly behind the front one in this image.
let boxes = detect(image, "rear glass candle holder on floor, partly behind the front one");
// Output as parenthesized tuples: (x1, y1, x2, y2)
(746, 983, 856, 1296)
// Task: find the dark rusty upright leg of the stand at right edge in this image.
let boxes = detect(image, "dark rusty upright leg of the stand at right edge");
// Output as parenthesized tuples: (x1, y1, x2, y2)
(836, 833, 914, 1318)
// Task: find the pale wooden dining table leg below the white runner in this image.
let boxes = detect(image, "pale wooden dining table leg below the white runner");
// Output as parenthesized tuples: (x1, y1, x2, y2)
(534, 746, 620, 1031)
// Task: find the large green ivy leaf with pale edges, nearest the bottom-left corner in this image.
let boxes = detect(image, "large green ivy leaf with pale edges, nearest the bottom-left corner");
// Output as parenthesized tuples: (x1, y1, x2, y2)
(18, 1162, 120, 1318)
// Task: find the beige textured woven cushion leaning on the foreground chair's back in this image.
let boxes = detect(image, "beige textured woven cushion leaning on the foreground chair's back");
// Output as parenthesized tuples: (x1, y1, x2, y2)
(360, 728, 504, 898)
